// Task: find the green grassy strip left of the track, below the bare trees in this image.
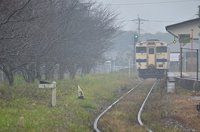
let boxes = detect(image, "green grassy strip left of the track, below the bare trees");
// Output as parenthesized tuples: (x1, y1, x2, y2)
(0, 73, 138, 132)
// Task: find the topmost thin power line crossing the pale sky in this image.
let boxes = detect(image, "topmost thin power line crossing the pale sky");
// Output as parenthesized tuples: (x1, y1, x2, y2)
(112, 0, 200, 6)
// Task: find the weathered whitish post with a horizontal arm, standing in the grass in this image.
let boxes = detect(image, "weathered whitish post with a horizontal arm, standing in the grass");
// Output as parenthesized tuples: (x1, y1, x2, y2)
(38, 81, 56, 107)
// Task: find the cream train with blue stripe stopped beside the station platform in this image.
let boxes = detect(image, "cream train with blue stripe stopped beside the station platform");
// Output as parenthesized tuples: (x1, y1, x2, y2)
(136, 39, 170, 79)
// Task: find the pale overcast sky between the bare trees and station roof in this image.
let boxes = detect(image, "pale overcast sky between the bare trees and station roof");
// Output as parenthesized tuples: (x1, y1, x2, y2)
(96, 0, 200, 33)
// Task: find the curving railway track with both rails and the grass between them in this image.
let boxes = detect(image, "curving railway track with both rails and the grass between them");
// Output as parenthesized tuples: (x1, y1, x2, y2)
(94, 79, 157, 132)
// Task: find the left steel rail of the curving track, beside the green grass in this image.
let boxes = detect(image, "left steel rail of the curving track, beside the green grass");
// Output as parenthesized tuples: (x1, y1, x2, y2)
(94, 81, 144, 132)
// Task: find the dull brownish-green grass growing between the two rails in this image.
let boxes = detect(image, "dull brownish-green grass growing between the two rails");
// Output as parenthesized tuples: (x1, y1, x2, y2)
(99, 80, 153, 132)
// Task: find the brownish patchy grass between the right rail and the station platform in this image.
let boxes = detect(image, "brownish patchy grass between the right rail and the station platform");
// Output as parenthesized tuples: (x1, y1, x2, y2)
(142, 81, 200, 132)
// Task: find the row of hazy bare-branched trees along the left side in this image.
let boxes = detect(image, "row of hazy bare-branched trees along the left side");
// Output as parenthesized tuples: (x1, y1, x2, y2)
(0, 0, 120, 85)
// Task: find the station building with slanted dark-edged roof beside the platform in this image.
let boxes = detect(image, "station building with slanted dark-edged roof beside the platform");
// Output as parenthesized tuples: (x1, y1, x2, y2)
(166, 18, 200, 71)
